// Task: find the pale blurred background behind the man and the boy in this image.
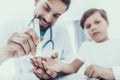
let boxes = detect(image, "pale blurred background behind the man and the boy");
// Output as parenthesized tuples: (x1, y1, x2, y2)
(0, 0, 120, 76)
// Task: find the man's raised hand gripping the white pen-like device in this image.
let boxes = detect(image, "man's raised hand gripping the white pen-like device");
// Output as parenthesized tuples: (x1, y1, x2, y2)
(7, 29, 39, 57)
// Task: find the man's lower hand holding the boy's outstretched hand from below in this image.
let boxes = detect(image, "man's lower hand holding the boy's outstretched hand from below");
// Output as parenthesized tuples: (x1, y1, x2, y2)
(30, 53, 58, 79)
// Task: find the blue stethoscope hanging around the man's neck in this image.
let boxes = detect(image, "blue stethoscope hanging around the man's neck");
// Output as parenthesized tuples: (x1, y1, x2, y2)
(28, 17, 54, 50)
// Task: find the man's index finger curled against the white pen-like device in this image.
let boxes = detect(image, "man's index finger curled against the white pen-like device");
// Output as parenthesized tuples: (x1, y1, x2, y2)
(25, 28, 40, 45)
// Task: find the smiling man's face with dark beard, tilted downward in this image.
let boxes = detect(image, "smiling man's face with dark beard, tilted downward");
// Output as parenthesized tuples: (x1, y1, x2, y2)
(34, 0, 67, 31)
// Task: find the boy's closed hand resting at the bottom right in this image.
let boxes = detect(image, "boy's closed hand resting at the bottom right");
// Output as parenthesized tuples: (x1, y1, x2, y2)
(85, 65, 115, 80)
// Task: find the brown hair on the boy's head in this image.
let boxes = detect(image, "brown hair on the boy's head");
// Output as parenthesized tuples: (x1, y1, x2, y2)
(80, 8, 108, 29)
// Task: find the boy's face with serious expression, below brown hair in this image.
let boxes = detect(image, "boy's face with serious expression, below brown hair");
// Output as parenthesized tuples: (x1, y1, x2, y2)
(84, 12, 108, 42)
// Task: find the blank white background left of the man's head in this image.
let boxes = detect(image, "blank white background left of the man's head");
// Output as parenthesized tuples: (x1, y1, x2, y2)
(0, 0, 34, 29)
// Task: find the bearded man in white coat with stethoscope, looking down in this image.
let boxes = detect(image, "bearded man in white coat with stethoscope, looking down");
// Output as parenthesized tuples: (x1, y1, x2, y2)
(2, 0, 74, 77)
